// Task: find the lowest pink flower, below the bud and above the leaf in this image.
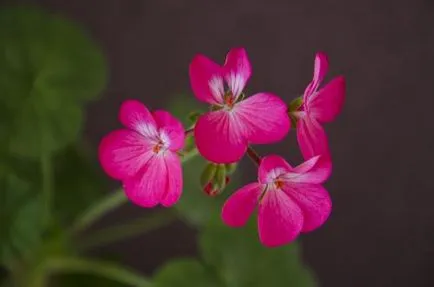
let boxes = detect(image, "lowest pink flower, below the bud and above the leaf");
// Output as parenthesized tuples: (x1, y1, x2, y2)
(222, 155, 332, 247)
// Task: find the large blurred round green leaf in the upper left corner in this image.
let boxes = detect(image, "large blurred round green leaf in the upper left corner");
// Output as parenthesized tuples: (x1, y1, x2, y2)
(0, 8, 106, 157)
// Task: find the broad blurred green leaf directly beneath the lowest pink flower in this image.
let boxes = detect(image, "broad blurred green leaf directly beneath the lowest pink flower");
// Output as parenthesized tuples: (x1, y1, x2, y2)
(199, 218, 316, 287)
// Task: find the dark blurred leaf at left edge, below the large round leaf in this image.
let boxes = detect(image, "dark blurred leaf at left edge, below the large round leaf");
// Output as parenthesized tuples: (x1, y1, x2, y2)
(0, 170, 44, 265)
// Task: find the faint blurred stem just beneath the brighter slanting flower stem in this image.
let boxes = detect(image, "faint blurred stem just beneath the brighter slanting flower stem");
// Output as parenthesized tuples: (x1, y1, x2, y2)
(78, 209, 176, 251)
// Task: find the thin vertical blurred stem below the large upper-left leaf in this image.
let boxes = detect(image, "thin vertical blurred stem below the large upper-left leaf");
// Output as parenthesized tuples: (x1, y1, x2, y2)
(41, 154, 53, 225)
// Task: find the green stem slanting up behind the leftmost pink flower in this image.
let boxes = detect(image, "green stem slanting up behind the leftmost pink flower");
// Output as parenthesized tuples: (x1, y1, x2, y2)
(72, 149, 198, 232)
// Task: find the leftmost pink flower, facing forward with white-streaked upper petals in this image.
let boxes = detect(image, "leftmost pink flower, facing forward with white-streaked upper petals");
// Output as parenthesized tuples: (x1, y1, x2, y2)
(99, 100, 184, 207)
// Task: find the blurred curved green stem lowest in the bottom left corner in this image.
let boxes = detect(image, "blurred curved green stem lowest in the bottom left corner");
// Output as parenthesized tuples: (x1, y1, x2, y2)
(44, 258, 152, 287)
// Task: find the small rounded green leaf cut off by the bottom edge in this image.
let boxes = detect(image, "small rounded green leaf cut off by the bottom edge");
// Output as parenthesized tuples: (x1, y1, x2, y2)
(154, 258, 220, 287)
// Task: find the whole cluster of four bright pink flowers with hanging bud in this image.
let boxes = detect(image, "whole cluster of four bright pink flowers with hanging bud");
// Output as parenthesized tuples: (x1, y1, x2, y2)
(99, 48, 345, 247)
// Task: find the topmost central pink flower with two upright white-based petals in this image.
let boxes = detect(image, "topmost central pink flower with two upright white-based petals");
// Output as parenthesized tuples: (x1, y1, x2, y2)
(190, 48, 290, 163)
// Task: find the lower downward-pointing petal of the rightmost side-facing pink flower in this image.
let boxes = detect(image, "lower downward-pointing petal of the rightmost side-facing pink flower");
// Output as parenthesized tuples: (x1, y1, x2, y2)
(297, 115, 330, 159)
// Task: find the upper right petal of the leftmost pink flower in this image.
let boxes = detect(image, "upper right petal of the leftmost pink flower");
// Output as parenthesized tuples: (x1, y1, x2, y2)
(153, 111, 185, 151)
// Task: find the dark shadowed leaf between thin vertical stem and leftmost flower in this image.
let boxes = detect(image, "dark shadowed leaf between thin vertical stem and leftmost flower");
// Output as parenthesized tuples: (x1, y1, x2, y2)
(53, 145, 108, 224)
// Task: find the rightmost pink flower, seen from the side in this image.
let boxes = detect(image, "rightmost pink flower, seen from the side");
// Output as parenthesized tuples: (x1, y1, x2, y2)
(294, 52, 345, 159)
